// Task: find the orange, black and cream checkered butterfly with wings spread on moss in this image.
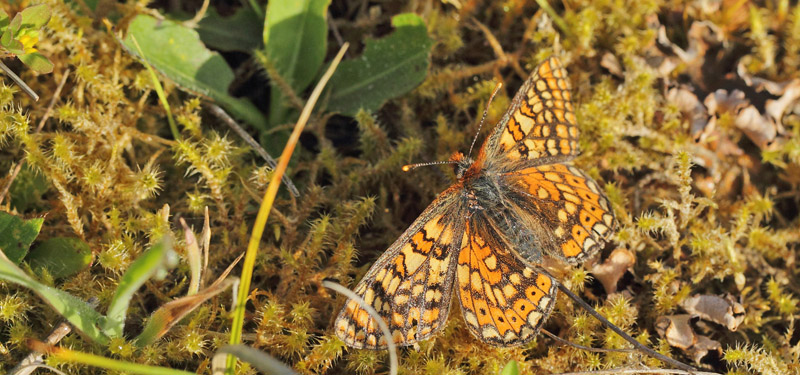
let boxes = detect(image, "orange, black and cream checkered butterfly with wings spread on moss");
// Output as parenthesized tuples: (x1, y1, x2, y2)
(334, 57, 617, 349)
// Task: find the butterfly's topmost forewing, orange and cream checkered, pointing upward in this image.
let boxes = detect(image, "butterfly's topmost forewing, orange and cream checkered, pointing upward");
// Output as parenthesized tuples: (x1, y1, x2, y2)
(484, 57, 578, 170)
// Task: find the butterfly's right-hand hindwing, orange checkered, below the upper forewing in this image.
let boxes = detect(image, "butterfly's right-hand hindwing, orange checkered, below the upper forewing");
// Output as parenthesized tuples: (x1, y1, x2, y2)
(503, 164, 617, 264)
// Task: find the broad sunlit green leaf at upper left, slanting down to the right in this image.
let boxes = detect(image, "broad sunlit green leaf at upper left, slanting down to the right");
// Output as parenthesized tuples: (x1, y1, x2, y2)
(122, 15, 267, 130)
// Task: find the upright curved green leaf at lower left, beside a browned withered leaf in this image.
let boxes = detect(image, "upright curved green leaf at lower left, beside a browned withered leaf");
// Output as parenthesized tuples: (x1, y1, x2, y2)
(102, 236, 177, 337)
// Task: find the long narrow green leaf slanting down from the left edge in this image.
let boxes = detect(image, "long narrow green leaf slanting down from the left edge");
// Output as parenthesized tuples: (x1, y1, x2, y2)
(0, 252, 109, 345)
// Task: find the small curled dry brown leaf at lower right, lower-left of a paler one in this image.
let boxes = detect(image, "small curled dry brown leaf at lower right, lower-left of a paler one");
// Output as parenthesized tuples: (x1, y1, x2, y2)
(656, 314, 722, 363)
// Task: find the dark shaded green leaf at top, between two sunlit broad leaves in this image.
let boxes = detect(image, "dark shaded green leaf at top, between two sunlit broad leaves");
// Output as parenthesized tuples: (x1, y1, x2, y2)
(197, 7, 264, 52)
